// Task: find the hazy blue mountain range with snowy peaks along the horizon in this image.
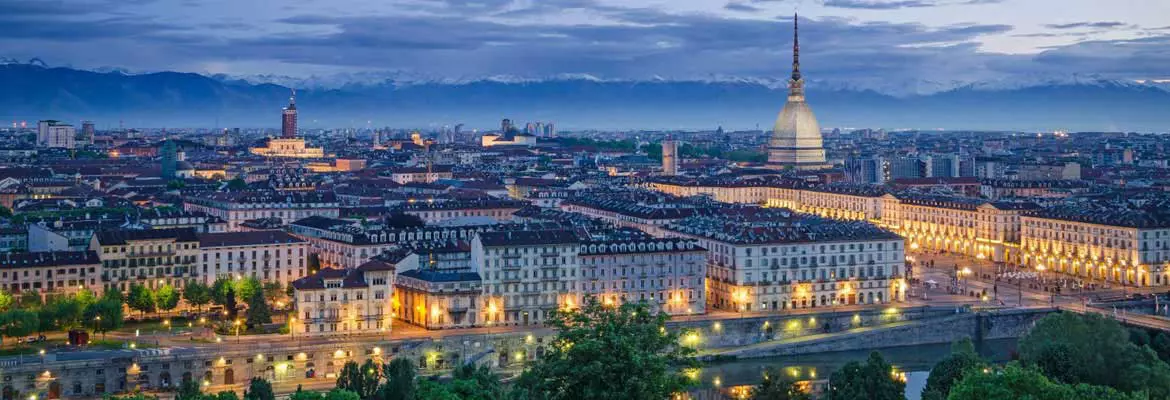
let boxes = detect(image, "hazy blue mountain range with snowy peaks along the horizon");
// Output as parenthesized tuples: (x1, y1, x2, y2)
(0, 63, 1170, 132)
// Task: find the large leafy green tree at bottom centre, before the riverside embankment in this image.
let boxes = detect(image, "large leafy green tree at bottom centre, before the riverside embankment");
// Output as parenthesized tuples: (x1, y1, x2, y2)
(515, 297, 696, 400)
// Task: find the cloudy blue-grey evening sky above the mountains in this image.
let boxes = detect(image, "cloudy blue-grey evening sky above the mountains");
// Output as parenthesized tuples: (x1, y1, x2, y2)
(0, 0, 1170, 84)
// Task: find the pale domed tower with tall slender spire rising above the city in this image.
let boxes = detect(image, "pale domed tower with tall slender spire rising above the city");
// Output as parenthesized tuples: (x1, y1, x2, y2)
(768, 15, 828, 170)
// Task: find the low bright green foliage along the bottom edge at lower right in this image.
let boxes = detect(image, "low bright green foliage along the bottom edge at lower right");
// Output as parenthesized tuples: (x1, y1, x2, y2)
(948, 363, 1147, 400)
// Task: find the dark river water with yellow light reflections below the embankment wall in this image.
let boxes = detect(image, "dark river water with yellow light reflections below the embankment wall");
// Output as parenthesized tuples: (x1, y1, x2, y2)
(690, 339, 1017, 400)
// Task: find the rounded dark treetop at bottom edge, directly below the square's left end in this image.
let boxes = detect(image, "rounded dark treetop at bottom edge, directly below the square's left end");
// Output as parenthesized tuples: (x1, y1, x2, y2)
(828, 351, 906, 400)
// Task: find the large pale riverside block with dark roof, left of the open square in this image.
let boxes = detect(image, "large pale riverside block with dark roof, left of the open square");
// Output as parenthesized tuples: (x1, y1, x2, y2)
(667, 208, 907, 311)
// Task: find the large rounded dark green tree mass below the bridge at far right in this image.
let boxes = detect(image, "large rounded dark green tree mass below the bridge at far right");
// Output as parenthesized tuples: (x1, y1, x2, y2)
(1019, 312, 1170, 399)
